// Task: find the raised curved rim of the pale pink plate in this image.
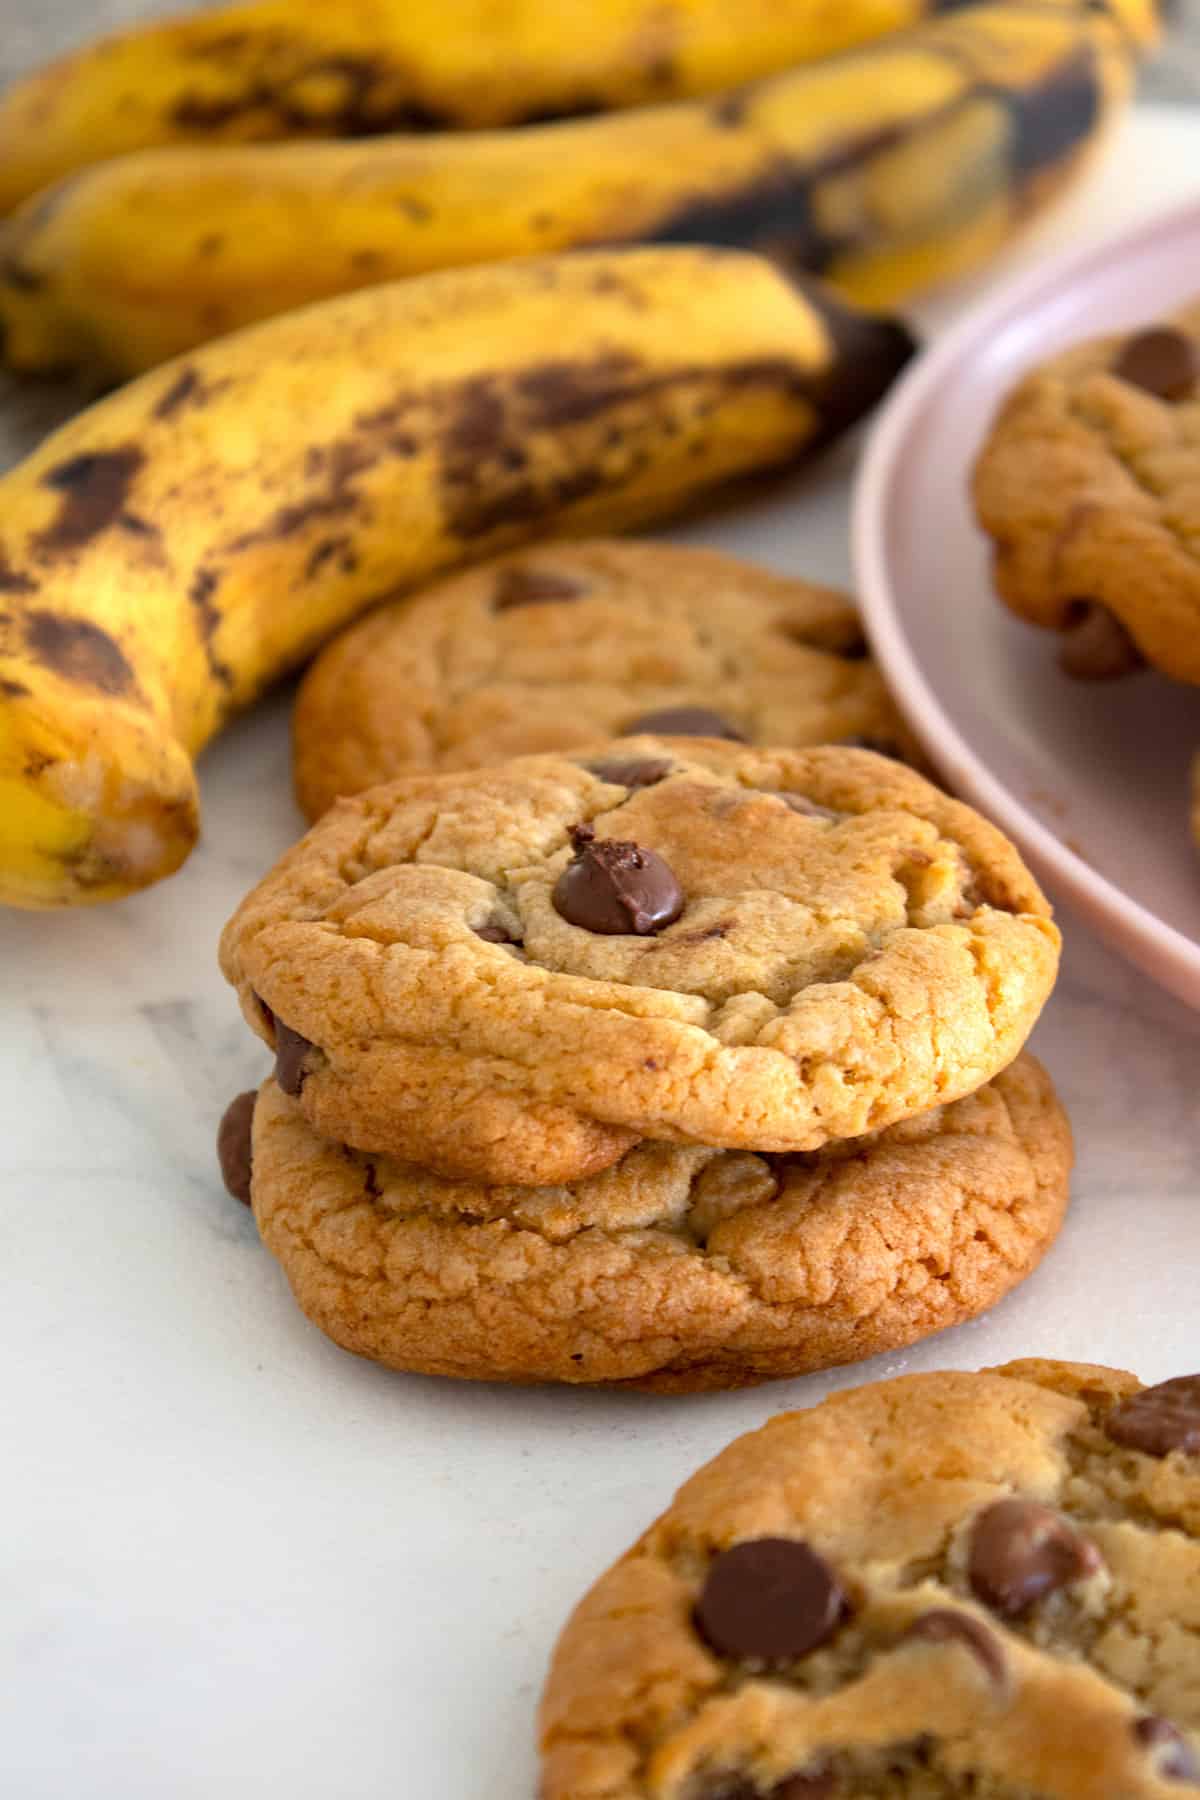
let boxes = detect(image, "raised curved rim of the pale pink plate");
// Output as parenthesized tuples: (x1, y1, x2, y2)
(851, 198, 1200, 1006)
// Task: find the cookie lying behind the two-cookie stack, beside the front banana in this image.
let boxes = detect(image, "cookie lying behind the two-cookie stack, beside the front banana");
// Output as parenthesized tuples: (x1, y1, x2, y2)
(293, 538, 910, 819)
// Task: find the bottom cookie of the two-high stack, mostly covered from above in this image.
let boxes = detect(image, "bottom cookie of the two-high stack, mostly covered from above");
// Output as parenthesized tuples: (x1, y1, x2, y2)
(223, 1057, 1072, 1393)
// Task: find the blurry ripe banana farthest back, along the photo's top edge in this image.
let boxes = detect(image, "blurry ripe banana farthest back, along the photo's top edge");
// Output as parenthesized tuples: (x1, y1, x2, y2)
(0, 0, 985, 212)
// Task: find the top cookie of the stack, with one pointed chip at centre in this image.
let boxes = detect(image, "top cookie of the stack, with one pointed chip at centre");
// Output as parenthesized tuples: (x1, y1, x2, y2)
(221, 736, 1058, 1184)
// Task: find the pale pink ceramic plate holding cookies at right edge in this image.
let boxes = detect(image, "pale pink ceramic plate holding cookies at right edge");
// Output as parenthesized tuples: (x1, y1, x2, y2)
(853, 203, 1200, 1006)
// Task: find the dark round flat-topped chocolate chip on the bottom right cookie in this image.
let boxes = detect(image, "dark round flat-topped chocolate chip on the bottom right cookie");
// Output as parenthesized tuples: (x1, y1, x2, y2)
(696, 1537, 849, 1663)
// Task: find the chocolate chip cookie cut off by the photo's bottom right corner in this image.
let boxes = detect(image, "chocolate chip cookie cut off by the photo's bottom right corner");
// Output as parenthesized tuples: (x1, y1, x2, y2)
(542, 1361, 1200, 1800)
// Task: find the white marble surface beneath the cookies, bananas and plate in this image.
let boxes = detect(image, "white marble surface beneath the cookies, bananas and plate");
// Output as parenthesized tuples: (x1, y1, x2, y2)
(0, 115, 1200, 1800)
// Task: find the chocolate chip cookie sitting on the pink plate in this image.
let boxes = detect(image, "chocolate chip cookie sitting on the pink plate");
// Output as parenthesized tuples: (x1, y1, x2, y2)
(973, 304, 1200, 682)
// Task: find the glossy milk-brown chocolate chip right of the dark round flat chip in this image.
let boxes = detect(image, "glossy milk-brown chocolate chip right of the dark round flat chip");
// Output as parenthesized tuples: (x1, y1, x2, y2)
(966, 1496, 1103, 1618)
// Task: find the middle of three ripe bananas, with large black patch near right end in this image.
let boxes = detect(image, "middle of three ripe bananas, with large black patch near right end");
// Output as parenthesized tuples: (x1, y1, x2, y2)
(0, 0, 1153, 374)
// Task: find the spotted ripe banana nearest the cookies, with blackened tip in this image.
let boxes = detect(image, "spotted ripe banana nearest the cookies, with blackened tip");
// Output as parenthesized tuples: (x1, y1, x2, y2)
(0, 247, 912, 905)
